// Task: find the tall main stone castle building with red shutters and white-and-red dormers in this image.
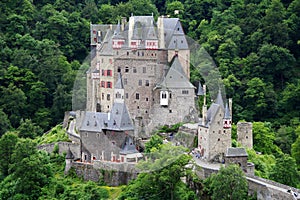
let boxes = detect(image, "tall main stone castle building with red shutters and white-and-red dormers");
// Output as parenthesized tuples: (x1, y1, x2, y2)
(86, 16, 198, 138)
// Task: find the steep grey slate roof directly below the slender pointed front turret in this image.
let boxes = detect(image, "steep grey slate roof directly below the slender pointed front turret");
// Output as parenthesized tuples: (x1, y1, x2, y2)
(106, 103, 134, 131)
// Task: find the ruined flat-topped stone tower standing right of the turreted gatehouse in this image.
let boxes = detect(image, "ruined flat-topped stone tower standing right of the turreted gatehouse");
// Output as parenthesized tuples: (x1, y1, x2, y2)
(237, 122, 253, 149)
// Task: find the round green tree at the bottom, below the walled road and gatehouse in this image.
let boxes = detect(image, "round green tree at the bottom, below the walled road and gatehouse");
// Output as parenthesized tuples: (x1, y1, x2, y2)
(211, 165, 248, 199)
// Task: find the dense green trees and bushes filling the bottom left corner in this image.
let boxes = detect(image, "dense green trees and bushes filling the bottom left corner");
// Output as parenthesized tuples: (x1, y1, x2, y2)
(0, 133, 115, 200)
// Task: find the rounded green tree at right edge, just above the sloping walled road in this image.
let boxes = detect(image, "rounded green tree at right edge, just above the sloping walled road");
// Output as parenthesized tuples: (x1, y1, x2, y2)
(270, 154, 300, 187)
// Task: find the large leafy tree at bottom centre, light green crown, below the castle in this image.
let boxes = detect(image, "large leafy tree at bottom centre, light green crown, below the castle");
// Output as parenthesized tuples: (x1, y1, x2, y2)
(120, 143, 196, 200)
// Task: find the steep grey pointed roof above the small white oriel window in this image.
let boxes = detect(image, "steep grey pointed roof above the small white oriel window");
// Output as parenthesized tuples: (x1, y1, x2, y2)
(158, 56, 194, 88)
